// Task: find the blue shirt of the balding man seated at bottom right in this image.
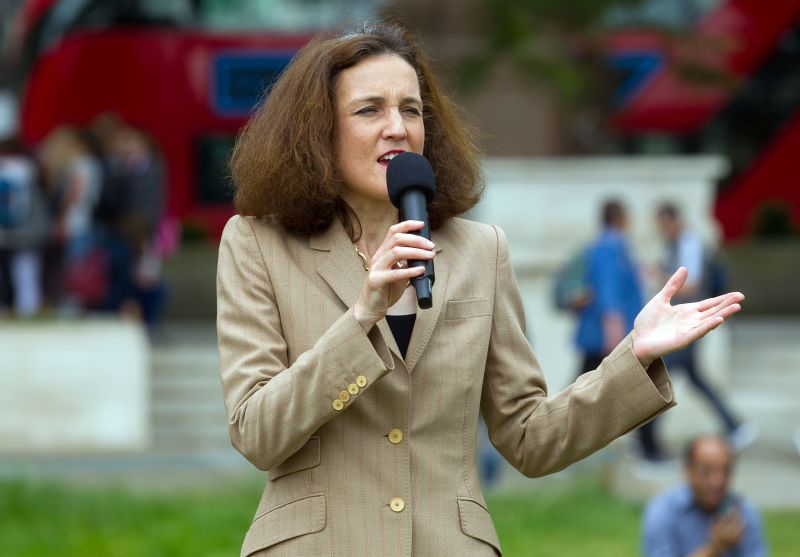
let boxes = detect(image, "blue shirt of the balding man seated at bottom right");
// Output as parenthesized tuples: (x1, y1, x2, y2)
(642, 485, 767, 557)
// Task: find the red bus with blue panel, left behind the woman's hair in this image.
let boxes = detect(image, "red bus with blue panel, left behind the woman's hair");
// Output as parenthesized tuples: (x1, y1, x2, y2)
(16, 0, 371, 237)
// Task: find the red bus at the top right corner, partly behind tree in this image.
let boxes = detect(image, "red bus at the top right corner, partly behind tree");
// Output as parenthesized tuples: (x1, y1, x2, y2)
(609, 0, 800, 241)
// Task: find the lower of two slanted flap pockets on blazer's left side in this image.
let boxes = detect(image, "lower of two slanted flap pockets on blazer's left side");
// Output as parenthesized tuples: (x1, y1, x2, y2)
(241, 493, 325, 557)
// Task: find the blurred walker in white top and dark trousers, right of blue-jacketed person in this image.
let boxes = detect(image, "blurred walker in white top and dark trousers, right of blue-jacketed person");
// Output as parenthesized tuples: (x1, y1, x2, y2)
(639, 203, 757, 460)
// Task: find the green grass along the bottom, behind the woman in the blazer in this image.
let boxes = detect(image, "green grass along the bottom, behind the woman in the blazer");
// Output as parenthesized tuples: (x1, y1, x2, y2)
(0, 480, 800, 557)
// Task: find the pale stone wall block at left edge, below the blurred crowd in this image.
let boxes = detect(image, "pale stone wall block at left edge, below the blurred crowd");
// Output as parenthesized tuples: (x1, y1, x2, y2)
(0, 318, 150, 454)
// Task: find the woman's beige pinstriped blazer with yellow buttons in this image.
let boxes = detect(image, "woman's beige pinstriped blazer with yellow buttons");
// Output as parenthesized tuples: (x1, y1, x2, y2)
(217, 217, 674, 557)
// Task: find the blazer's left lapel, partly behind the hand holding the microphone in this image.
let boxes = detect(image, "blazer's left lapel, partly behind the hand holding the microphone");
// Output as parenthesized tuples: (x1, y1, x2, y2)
(309, 219, 403, 361)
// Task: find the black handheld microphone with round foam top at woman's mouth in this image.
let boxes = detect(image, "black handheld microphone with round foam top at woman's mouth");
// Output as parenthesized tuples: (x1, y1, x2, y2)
(386, 152, 436, 309)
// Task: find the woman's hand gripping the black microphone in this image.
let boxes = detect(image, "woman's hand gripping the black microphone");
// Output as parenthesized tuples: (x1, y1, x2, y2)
(353, 220, 434, 332)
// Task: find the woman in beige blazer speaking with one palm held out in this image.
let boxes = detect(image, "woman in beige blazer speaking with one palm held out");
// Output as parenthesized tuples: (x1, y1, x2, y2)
(217, 23, 743, 556)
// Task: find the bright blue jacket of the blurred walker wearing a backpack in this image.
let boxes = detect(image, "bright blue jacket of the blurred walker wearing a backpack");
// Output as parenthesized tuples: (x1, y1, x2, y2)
(575, 228, 643, 355)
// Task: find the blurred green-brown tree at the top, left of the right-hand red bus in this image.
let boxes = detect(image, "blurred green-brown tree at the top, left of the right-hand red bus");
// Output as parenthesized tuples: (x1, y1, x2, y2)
(460, 0, 730, 153)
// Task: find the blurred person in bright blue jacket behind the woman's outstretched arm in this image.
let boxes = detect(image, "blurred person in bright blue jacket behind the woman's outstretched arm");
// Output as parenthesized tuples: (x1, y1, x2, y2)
(575, 199, 644, 373)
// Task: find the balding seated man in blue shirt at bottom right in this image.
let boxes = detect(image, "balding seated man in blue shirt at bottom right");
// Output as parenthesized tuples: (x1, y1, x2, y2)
(643, 437, 767, 557)
